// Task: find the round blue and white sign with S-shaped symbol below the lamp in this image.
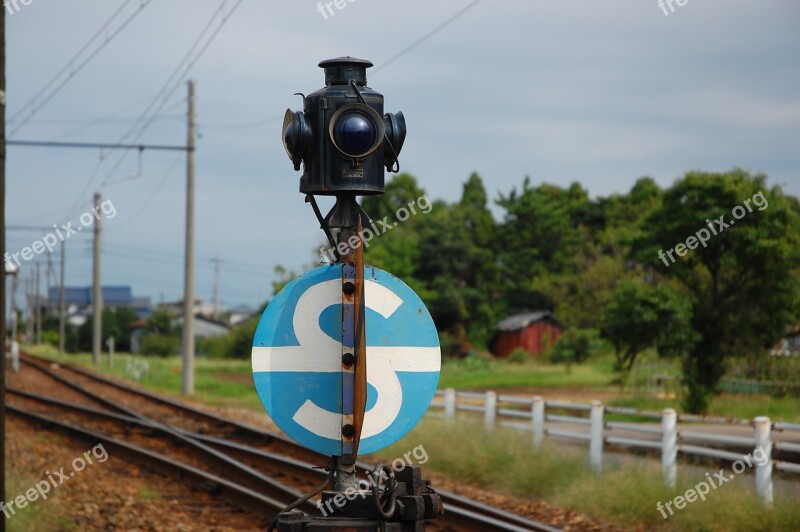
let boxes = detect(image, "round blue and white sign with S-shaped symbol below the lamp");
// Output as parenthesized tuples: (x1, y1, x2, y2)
(252, 264, 441, 456)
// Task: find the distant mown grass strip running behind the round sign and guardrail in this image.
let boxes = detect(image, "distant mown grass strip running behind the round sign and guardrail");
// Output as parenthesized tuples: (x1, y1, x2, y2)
(26, 345, 800, 422)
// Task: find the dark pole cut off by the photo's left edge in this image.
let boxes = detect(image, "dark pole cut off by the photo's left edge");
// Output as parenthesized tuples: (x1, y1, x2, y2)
(0, 6, 6, 532)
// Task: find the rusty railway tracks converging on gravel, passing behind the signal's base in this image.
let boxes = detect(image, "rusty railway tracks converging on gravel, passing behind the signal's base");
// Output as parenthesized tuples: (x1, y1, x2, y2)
(15, 354, 557, 531)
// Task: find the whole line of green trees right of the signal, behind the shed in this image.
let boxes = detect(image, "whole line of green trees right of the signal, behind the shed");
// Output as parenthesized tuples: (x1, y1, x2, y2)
(362, 169, 800, 412)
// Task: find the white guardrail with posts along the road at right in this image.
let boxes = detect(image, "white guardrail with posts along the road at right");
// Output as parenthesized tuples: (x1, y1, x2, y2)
(431, 388, 800, 506)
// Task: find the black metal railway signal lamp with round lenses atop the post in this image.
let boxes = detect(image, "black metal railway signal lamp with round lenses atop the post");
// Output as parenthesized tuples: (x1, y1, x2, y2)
(283, 57, 406, 195)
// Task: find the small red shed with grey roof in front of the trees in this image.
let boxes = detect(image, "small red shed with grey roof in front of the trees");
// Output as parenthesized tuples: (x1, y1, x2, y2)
(490, 311, 561, 357)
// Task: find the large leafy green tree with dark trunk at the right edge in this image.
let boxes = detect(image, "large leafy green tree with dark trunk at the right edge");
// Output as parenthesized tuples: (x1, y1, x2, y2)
(633, 169, 800, 412)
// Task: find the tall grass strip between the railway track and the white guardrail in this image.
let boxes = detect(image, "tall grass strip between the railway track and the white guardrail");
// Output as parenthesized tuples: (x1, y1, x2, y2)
(379, 419, 800, 531)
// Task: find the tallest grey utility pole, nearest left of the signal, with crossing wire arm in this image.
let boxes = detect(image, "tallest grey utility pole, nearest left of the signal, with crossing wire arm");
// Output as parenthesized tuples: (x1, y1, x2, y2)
(181, 80, 195, 395)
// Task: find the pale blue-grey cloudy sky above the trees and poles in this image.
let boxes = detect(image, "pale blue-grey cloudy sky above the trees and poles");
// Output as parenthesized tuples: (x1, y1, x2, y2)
(6, 0, 800, 307)
